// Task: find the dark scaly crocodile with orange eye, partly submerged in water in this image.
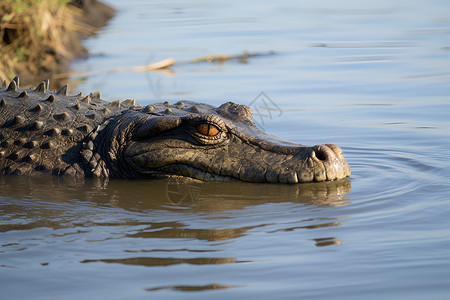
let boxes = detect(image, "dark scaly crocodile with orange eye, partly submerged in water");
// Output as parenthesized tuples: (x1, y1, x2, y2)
(0, 77, 350, 184)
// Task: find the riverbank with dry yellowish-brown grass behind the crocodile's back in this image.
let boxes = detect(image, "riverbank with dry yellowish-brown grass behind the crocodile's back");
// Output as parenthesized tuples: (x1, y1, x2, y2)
(0, 0, 115, 87)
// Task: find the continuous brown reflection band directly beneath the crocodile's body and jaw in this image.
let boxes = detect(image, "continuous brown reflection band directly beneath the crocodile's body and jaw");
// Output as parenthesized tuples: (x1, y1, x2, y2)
(0, 177, 351, 213)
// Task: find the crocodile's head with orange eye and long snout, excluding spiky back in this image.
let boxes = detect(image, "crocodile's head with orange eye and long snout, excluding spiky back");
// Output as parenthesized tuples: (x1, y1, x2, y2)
(102, 101, 350, 183)
